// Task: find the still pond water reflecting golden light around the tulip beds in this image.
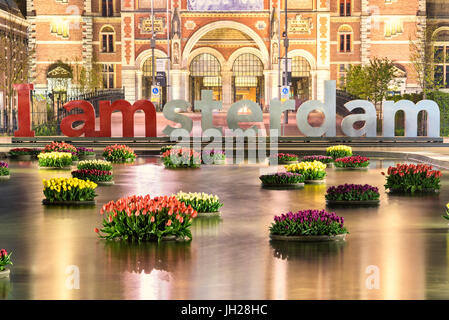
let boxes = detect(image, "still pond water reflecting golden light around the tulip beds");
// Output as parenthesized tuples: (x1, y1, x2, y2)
(0, 157, 449, 299)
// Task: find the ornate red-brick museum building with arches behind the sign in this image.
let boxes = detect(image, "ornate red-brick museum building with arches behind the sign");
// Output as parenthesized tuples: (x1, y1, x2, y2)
(27, 0, 430, 109)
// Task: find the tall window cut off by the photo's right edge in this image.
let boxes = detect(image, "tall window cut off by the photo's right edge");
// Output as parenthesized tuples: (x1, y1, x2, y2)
(433, 28, 449, 88)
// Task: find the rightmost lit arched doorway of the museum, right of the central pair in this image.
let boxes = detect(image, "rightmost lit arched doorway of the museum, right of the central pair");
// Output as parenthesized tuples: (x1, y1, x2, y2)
(290, 56, 312, 109)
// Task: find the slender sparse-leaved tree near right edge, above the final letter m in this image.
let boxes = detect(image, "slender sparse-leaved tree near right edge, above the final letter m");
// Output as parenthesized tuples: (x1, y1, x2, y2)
(409, 24, 443, 99)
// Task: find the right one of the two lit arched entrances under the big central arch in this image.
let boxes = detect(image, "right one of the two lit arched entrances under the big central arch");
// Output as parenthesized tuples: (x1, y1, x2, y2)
(232, 53, 264, 105)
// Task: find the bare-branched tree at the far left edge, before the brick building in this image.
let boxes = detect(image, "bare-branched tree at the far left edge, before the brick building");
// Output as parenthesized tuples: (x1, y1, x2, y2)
(0, 13, 32, 133)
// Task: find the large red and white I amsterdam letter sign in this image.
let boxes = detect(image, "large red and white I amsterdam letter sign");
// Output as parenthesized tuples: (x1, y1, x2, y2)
(14, 80, 440, 137)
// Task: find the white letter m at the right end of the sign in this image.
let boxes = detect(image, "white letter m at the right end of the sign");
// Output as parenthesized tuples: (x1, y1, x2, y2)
(382, 100, 440, 137)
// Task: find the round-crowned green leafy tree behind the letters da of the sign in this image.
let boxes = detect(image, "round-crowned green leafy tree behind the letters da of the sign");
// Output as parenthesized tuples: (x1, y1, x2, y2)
(343, 58, 396, 116)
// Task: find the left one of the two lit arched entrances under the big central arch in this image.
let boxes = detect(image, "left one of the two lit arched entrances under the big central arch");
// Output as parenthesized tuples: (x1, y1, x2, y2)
(189, 53, 222, 105)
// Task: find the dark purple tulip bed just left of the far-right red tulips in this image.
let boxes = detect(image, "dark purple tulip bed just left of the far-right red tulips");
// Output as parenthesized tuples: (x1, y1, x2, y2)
(325, 184, 380, 205)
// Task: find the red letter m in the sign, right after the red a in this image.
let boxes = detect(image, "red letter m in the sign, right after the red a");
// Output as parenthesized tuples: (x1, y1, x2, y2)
(100, 100, 157, 137)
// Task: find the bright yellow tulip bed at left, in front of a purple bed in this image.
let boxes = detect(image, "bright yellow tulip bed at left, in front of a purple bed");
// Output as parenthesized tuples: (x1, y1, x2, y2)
(42, 178, 97, 204)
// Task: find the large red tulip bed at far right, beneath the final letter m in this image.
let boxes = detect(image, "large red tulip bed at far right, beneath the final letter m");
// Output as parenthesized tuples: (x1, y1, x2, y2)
(382, 164, 442, 194)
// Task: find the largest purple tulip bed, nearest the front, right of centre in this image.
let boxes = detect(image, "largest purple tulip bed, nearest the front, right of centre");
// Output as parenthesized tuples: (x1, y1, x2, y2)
(270, 210, 348, 241)
